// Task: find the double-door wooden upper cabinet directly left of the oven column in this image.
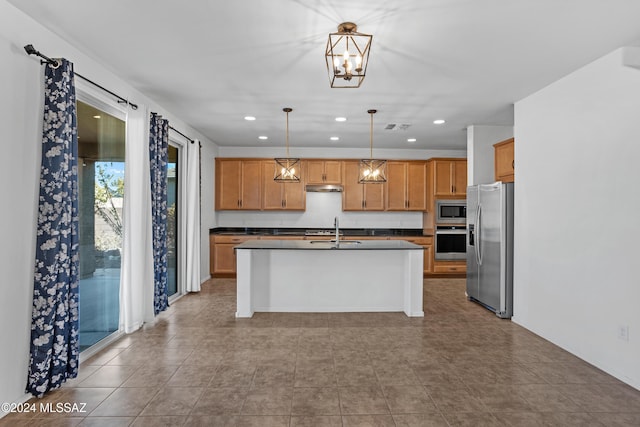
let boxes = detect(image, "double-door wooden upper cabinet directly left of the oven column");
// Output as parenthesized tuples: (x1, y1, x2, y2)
(386, 161, 427, 211)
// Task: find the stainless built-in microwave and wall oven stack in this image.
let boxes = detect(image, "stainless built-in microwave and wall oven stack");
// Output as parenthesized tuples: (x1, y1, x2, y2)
(434, 200, 467, 261)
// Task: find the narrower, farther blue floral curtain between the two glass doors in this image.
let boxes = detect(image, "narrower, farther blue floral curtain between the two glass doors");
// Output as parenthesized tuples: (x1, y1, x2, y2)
(149, 113, 169, 314)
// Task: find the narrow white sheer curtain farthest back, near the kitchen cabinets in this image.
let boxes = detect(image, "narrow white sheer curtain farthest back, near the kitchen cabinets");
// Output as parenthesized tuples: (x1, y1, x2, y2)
(185, 140, 200, 292)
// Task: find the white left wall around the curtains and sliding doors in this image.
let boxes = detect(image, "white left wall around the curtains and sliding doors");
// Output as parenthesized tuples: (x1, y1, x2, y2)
(0, 0, 216, 416)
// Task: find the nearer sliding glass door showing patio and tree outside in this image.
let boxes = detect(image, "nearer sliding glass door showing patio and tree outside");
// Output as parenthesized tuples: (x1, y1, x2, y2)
(77, 101, 125, 351)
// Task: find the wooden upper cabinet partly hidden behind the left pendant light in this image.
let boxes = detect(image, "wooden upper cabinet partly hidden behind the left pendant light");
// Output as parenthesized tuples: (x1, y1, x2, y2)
(262, 160, 306, 211)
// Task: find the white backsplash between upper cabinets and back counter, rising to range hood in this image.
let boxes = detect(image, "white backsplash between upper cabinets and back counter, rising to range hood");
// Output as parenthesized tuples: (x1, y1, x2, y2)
(217, 193, 423, 228)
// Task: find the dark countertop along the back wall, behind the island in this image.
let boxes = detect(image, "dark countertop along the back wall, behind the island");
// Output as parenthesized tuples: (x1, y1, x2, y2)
(209, 227, 430, 237)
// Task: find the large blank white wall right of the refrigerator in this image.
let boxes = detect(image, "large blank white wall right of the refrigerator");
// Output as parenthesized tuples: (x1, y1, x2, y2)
(513, 48, 640, 388)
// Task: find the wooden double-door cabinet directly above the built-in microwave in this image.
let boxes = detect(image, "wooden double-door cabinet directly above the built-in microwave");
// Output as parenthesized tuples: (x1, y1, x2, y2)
(429, 159, 467, 198)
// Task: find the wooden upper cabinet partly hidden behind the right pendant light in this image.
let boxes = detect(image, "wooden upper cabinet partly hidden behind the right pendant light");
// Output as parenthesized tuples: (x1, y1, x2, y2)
(342, 160, 386, 211)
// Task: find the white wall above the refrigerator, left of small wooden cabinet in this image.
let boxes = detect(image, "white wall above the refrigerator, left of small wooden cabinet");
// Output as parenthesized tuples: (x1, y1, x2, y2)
(467, 125, 513, 185)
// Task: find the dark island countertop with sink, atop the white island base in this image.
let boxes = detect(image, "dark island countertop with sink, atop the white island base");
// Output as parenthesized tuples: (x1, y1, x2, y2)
(235, 240, 424, 251)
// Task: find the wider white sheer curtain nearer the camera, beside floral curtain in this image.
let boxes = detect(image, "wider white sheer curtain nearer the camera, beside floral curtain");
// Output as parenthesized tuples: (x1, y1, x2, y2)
(120, 105, 155, 333)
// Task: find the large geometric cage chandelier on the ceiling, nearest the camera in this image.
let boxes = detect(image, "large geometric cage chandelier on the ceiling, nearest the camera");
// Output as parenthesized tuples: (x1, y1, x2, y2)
(325, 22, 373, 88)
